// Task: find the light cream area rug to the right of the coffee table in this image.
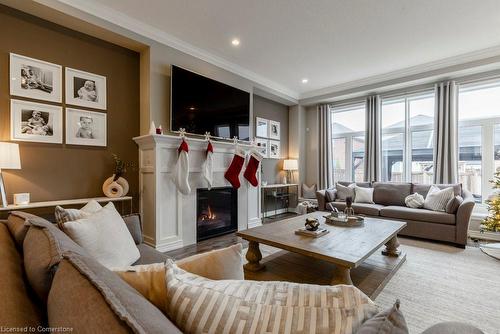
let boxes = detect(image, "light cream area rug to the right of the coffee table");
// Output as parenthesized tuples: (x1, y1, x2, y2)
(245, 238, 500, 334)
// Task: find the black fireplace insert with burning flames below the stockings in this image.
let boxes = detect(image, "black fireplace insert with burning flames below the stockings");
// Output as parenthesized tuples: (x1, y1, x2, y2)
(196, 187, 238, 241)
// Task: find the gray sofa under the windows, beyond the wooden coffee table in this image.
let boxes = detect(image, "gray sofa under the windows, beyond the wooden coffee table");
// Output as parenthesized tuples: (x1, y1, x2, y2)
(316, 182, 474, 247)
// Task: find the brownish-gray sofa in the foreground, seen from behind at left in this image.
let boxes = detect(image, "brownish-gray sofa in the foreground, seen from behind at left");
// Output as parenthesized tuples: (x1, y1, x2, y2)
(0, 212, 482, 334)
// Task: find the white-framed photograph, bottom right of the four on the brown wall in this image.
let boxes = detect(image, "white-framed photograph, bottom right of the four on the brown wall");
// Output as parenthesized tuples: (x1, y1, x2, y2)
(66, 108, 107, 146)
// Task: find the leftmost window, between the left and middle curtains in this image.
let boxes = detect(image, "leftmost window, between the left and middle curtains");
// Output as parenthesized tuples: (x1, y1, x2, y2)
(332, 103, 366, 182)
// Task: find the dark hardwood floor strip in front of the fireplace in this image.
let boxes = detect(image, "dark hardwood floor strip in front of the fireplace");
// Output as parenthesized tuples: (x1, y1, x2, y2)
(165, 213, 296, 260)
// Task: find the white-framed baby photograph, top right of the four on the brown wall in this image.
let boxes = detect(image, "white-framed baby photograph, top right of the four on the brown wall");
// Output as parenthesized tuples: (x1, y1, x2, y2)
(66, 67, 106, 110)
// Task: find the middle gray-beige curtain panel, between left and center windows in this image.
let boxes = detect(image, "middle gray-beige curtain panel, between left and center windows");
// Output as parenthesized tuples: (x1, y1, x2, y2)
(364, 95, 382, 182)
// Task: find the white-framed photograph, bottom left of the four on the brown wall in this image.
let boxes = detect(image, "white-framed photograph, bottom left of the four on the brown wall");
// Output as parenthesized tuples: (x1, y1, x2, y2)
(10, 100, 63, 144)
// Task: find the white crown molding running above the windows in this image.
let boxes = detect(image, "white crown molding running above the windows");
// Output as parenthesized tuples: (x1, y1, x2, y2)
(300, 45, 500, 100)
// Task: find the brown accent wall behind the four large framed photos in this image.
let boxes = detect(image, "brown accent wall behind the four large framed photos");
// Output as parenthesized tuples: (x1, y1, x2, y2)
(0, 6, 140, 209)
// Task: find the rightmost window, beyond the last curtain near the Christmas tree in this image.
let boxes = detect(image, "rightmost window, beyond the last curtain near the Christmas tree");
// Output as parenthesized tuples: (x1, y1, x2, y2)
(458, 81, 500, 203)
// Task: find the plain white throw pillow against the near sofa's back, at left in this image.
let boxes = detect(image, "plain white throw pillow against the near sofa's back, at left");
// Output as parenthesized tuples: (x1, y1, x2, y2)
(64, 202, 141, 268)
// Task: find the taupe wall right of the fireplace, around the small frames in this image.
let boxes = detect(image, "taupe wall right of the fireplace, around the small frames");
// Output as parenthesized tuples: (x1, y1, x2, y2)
(253, 95, 288, 184)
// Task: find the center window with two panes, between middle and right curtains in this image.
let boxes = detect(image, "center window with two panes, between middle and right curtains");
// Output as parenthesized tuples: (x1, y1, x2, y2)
(381, 92, 435, 183)
